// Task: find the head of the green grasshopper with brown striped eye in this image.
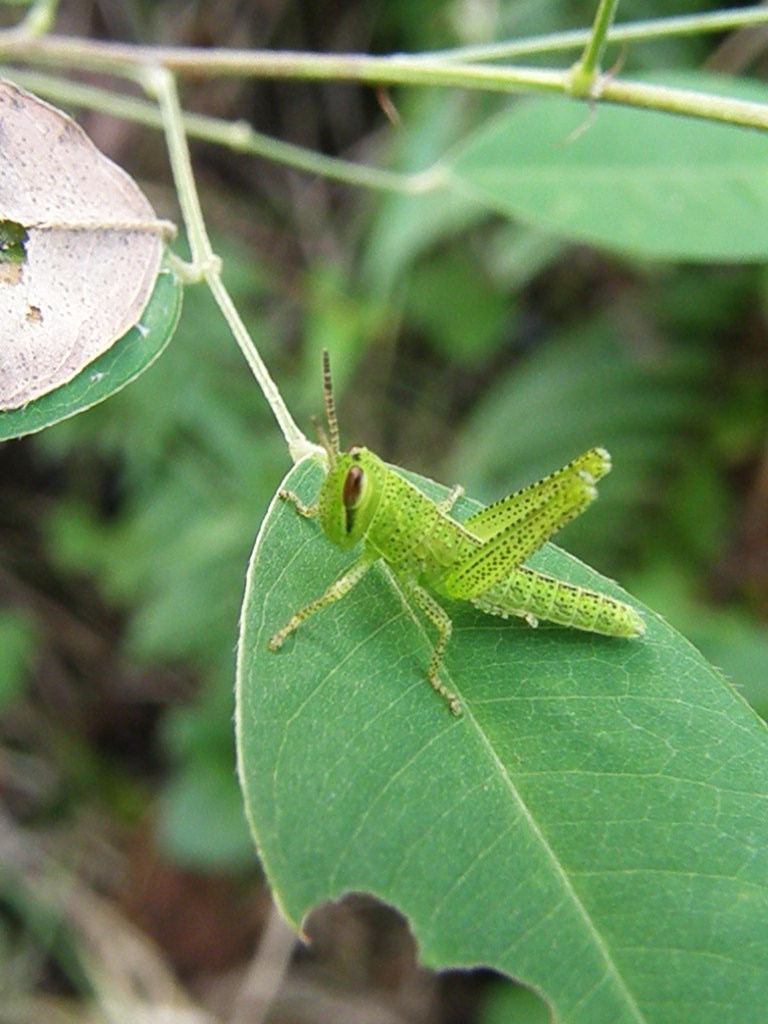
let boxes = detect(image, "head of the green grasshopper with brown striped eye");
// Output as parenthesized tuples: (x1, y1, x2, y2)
(317, 447, 387, 548)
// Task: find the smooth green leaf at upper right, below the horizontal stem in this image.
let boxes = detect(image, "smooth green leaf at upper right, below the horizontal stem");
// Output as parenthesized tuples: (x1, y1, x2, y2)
(446, 74, 768, 261)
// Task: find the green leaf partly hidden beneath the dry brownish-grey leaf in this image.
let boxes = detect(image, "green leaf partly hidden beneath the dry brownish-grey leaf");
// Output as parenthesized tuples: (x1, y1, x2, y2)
(0, 265, 183, 440)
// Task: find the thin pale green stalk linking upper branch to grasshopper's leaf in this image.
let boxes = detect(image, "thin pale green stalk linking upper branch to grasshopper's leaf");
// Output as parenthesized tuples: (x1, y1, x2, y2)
(137, 68, 318, 462)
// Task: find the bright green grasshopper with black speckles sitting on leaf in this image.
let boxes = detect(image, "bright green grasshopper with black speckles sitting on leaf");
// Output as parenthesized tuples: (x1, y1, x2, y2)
(267, 352, 645, 715)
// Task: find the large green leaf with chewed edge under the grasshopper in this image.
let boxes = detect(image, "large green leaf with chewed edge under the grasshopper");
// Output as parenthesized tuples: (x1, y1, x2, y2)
(238, 463, 768, 1024)
